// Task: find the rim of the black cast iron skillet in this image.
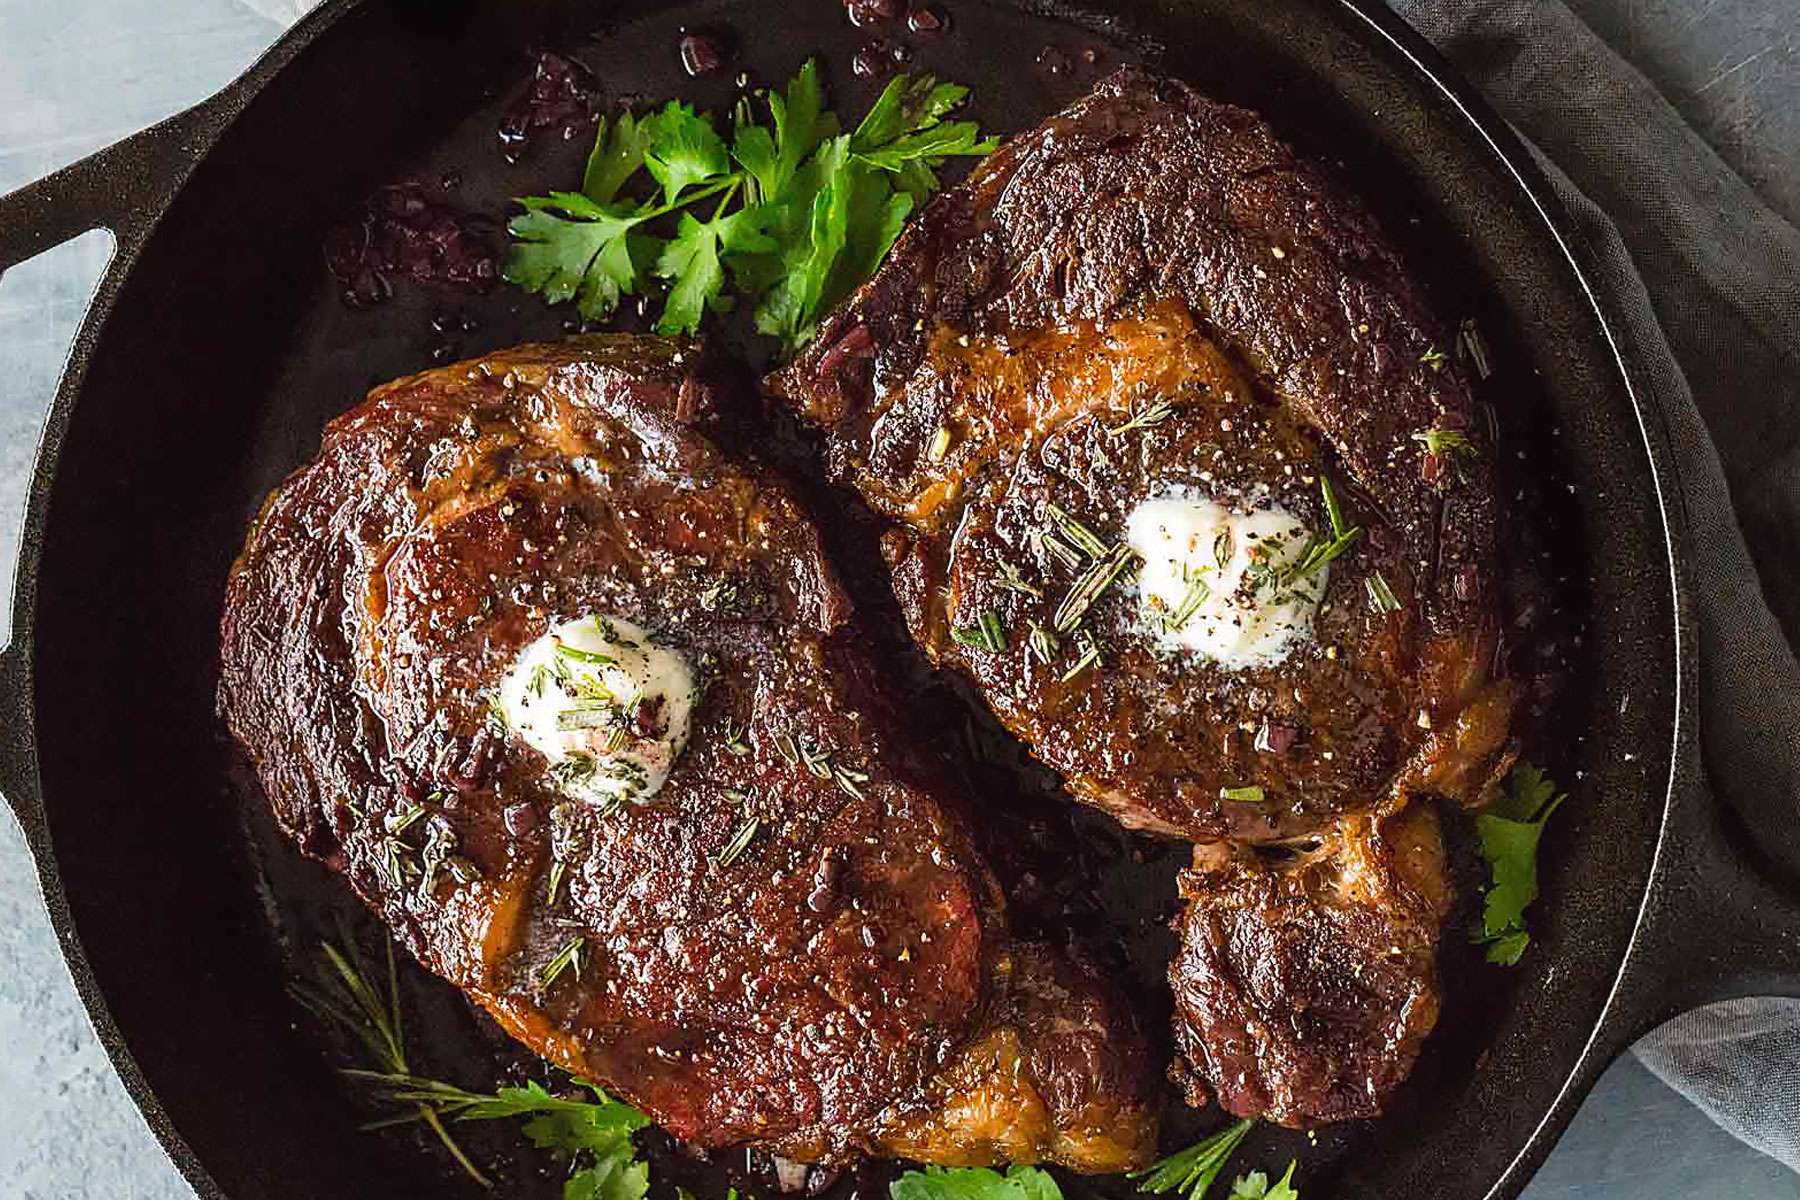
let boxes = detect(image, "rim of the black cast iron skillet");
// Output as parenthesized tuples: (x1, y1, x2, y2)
(0, 0, 1699, 1200)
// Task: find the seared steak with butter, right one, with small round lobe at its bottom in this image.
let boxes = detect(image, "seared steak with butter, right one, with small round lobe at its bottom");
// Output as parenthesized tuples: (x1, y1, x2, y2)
(772, 70, 1514, 1123)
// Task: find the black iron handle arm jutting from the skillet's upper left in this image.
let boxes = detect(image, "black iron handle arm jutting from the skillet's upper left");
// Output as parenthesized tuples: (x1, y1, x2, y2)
(0, 103, 216, 275)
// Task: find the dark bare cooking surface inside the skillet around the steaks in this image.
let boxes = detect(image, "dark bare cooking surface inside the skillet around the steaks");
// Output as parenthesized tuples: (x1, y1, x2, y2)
(21, 0, 1676, 1200)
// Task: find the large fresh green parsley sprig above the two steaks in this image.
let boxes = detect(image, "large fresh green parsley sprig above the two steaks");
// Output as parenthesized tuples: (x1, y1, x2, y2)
(506, 59, 995, 349)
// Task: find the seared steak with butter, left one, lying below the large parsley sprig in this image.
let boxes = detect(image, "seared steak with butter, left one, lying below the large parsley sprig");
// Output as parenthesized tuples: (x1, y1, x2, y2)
(220, 338, 1156, 1171)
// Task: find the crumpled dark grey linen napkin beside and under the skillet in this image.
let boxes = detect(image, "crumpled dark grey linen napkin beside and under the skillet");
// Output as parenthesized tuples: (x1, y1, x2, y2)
(1390, 0, 1800, 1171)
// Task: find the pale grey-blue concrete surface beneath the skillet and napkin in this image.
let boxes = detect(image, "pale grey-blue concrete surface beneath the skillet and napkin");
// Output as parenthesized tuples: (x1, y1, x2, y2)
(0, 0, 1800, 1200)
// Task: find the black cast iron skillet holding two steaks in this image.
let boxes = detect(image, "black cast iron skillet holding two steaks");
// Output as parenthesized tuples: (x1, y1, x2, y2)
(0, 0, 1800, 1200)
